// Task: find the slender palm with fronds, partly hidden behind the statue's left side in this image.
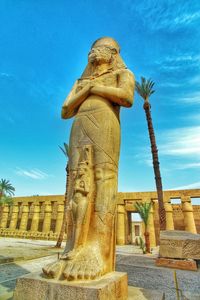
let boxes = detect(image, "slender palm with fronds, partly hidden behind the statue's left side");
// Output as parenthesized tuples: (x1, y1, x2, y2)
(56, 143, 71, 248)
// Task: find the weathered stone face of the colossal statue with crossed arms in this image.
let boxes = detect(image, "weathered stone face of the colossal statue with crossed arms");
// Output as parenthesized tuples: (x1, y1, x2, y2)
(88, 46, 112, 64)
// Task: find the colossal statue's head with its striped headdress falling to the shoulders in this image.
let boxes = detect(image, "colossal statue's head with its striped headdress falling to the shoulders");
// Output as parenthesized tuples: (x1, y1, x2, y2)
(82, 37, 126, 78)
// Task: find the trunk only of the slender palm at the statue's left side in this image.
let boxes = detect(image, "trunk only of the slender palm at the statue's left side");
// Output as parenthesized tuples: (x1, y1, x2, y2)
(56, 163, 69, 248)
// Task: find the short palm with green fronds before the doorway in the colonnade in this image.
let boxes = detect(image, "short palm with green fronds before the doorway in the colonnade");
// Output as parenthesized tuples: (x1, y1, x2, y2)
(135, 202, 151, 253)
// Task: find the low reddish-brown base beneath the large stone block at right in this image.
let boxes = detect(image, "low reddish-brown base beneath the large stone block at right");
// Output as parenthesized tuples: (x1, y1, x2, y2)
(156, 258, 197, 271)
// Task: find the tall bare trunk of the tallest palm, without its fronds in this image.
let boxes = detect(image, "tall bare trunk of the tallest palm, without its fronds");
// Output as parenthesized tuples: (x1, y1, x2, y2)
(143, 101, 166, 230)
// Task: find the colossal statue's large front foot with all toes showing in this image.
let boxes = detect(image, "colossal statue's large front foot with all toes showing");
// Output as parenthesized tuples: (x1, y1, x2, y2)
(63, 245, 105, 280)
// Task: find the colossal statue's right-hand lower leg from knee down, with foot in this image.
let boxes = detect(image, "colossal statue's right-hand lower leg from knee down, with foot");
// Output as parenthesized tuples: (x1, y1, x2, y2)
(63, 164, 117, 280)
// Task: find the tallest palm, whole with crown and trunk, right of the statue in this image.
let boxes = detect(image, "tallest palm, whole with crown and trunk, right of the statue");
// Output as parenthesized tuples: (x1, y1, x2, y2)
(136, 77, 166, 230)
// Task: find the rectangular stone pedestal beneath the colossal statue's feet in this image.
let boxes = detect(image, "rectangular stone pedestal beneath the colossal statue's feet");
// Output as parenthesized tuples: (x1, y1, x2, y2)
(13, 272, 128, 300)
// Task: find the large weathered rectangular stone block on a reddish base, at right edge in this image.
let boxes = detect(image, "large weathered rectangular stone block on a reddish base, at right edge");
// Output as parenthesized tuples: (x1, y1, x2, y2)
(159, 230, 200, 259)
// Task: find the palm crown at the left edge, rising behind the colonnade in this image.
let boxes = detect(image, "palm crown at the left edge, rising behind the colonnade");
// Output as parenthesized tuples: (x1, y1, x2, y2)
(0, 179, 15, 205)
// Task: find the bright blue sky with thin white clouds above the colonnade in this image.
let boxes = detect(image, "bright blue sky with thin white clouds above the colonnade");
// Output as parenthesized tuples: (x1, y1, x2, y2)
(0, 0, 200, 196)
